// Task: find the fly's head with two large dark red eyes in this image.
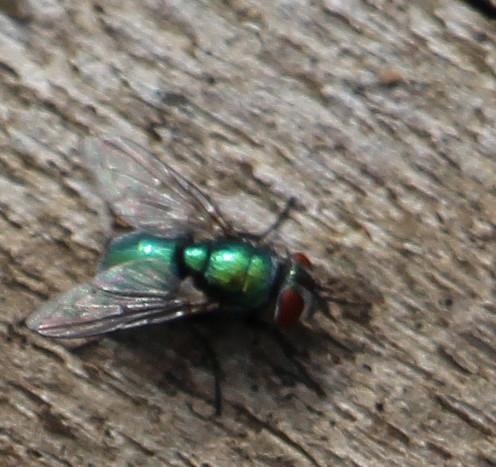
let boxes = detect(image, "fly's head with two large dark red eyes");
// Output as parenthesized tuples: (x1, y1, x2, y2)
(274, 253, 321, 326)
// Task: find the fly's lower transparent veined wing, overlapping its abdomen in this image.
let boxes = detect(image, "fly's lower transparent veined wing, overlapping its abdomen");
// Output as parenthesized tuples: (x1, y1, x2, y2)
(26, 260, 216, 338)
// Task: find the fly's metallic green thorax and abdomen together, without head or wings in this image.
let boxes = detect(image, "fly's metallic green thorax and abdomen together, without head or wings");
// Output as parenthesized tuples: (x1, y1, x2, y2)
(100, 232, 279, 310)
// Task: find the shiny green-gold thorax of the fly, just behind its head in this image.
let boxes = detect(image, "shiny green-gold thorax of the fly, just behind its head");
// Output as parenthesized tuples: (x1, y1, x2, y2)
(183, 241, 277, 308)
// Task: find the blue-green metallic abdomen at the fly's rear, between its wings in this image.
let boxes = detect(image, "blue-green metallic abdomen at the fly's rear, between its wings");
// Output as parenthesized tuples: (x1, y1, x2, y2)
(99, 231, 187, 274)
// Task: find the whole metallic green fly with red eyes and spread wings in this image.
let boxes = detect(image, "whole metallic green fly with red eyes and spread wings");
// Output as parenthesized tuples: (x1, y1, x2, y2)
(27, 138, 384, 414)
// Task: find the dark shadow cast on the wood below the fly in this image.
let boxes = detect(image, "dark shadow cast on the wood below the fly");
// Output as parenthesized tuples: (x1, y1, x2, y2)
(72, 315, 358, 415)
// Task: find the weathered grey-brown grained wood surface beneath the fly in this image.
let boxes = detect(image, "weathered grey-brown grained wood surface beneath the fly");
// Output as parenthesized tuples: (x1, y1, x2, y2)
(0, 0, 496, 467)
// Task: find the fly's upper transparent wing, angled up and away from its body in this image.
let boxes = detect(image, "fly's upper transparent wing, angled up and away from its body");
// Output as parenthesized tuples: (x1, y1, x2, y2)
(84, 138, 232, 235)
